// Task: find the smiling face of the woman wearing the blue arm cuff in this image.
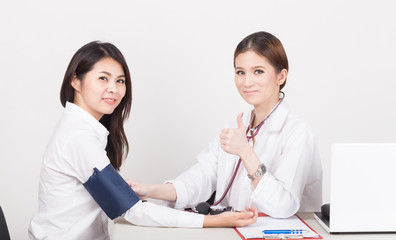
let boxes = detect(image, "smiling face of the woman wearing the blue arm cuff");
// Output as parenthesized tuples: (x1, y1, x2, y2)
(71, 57, 126, 120)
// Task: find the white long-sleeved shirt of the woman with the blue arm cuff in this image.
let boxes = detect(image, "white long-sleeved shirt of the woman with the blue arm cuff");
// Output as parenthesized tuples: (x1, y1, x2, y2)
(29, 102, 204, 240)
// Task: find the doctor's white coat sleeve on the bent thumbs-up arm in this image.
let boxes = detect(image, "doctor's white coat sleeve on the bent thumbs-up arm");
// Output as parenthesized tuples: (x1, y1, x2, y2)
(251, 122, 318, 218)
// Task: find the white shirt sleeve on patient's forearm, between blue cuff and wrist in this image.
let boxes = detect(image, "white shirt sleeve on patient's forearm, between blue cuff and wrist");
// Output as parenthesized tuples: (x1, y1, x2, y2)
(123, 201, 205, 228)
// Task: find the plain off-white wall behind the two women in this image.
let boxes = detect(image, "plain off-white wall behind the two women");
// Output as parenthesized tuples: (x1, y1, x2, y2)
(0, 0, 396, 239)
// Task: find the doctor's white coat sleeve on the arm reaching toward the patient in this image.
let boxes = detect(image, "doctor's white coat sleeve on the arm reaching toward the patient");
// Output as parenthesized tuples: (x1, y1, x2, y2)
(164, 140, 220, 209)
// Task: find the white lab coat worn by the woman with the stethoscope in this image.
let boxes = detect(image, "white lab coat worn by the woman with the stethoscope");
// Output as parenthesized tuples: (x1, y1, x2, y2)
(165, 102, 322, 218)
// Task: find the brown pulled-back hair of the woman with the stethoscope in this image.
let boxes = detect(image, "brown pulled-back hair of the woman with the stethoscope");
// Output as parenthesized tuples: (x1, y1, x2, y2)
(234, 31, 289, 90)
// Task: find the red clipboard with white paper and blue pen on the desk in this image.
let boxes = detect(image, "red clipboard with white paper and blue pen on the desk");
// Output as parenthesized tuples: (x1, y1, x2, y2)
(234, 213, 323, 240)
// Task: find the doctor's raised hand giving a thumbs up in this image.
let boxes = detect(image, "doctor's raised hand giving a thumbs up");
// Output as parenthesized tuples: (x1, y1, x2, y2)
(220, 113, 251, 157)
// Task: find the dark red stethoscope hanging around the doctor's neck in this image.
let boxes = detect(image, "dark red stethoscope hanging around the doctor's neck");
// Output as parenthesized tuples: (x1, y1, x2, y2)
(212, 91, 285, 206)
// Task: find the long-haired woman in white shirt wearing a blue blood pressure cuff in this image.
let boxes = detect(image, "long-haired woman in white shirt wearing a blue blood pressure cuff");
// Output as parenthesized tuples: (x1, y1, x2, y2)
(29, 42, 257, 240)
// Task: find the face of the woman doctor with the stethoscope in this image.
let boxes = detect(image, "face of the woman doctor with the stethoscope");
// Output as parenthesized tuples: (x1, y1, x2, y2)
(235, 50, 287, 111)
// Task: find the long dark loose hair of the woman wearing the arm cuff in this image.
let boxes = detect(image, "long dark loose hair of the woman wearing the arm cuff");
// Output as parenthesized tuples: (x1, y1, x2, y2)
(60, 41, 132, 170)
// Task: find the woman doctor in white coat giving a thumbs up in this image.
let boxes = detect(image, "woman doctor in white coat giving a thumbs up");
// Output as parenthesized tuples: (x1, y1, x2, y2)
(128, 32, 322, 218)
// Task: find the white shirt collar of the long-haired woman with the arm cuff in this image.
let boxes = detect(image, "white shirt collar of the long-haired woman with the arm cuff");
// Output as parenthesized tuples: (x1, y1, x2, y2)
(65, 102, 109, 141)
